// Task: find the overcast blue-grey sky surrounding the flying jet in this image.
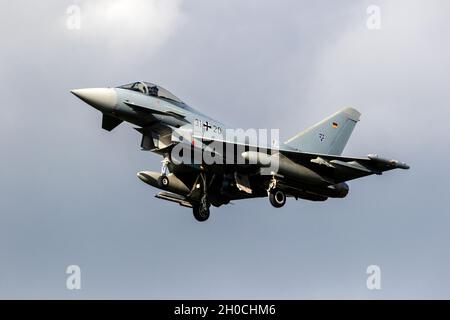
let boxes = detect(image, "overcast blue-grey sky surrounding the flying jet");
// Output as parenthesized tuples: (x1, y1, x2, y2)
(0, 0, 450, 299)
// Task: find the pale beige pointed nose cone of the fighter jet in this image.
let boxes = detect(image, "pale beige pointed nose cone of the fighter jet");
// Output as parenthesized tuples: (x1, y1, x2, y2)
(70, 88, 117, 112)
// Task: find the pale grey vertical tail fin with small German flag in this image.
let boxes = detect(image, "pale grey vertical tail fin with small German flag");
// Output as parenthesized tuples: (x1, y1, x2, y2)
(285, 108, 361, 155)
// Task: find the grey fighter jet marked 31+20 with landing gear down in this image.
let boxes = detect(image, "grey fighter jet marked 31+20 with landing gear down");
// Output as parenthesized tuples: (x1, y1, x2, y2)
(71, 82, 409, 222)
